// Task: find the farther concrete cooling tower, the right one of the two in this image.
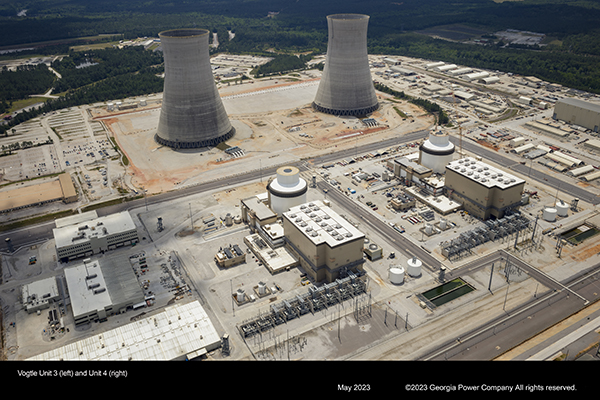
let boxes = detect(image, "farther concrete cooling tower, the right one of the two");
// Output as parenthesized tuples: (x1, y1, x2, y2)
(313, 14, 379, 116)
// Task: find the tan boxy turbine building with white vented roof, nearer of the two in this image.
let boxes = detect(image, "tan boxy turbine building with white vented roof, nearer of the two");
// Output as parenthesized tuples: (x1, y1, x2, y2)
(282, 201, 365, 282)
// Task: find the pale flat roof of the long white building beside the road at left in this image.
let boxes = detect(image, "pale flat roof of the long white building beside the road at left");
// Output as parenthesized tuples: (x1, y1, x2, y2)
(52, 211, 136, 248)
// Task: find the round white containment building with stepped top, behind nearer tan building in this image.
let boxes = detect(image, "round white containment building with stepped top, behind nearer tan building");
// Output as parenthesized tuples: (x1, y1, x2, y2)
(267, 166, 308, 215)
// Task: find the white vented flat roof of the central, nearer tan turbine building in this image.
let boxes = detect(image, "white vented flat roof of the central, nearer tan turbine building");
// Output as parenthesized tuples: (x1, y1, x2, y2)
(283, 200, 365, 247)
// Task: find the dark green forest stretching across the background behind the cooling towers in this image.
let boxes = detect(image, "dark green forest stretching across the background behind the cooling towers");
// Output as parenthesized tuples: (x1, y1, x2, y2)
(0, 0, 600, 130)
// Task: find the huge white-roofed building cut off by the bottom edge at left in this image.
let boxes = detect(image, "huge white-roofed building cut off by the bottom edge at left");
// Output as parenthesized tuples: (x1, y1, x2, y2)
(28, 301, 221, 361)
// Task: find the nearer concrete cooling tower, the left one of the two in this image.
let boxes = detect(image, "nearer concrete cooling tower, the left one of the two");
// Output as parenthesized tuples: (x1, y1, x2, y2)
(155, 29, 235, 149)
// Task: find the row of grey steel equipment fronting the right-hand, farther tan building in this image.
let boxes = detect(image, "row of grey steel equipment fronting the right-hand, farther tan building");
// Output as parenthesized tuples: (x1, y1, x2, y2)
(440, 212, 531, 261)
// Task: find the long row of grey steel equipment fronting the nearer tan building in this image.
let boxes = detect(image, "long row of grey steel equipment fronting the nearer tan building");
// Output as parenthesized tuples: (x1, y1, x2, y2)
(238, 271, 371, 339)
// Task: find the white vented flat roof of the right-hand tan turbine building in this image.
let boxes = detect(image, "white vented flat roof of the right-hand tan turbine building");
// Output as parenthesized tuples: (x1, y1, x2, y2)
(446, 157, 525, 189)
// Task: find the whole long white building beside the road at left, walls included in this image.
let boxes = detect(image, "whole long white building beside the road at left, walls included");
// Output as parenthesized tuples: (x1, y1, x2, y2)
(52, 211, 139, 262)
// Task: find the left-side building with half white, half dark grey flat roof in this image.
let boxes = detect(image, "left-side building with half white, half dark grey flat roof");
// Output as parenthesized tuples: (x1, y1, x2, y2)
(65, 257, 145, 325)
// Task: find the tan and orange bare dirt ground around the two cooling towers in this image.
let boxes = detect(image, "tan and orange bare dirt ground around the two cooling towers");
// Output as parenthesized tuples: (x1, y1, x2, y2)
(91, 79, 433, 194)
